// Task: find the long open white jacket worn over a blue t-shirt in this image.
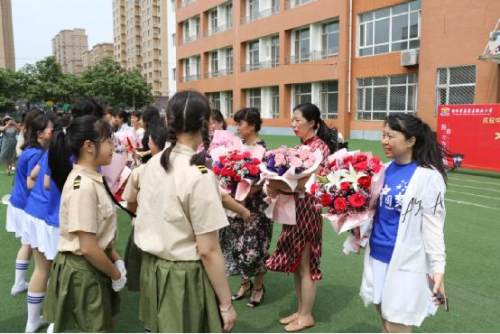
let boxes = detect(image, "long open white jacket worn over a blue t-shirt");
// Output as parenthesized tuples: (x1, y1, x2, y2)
(360, 167, 446, 326)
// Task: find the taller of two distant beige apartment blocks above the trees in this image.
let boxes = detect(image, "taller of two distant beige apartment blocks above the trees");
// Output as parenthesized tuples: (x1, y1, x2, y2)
(52, 28, 89, 74)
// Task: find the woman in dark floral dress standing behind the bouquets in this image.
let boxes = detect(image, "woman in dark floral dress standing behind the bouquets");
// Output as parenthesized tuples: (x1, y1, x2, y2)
(220, 108, 273, 308)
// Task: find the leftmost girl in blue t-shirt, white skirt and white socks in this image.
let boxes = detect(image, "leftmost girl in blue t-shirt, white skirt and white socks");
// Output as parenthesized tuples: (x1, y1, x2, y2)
(6, 112, 52, 295)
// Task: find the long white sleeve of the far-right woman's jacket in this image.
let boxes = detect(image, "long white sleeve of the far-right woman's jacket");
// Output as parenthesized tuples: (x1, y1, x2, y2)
(422, 171, 446, 274)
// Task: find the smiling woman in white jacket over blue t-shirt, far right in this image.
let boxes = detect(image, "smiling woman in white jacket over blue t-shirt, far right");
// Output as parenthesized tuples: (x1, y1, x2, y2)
(360, 114, 447, 332)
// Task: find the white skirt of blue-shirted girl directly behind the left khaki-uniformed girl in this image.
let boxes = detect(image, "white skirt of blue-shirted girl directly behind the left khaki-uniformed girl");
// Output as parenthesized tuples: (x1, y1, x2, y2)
(21, 214, 59, 261)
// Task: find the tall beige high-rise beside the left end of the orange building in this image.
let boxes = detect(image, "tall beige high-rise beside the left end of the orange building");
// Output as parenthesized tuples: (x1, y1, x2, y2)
(113, 0, 175, 96)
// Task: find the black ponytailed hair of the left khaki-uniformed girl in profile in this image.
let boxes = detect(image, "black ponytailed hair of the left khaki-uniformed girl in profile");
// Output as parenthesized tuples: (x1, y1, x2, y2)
(49, 115, 112, 191)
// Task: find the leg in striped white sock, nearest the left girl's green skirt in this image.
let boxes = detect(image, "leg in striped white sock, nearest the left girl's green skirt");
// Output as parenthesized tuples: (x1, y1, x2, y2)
(26, 249, 50, 333)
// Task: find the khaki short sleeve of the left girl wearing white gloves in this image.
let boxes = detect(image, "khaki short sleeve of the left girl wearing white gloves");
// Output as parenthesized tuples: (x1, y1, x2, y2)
(68, 178, 98, 234)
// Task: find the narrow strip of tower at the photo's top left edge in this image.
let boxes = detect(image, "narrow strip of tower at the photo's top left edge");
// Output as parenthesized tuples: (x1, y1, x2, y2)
(0, 0, 16, 70)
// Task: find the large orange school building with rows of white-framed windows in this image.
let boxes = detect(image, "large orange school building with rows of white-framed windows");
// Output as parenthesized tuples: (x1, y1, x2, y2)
(176, 0, 500, 139)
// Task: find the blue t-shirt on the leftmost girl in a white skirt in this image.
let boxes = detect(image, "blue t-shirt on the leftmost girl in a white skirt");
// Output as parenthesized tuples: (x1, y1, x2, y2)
(10, 147, 45, 210)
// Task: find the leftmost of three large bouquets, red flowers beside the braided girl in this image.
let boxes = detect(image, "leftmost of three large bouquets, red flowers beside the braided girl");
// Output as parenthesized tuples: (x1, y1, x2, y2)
(209, 130, 265, 201)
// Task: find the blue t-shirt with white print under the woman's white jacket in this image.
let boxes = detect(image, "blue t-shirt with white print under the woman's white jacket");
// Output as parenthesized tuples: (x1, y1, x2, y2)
(370, 162, 417, 263)
